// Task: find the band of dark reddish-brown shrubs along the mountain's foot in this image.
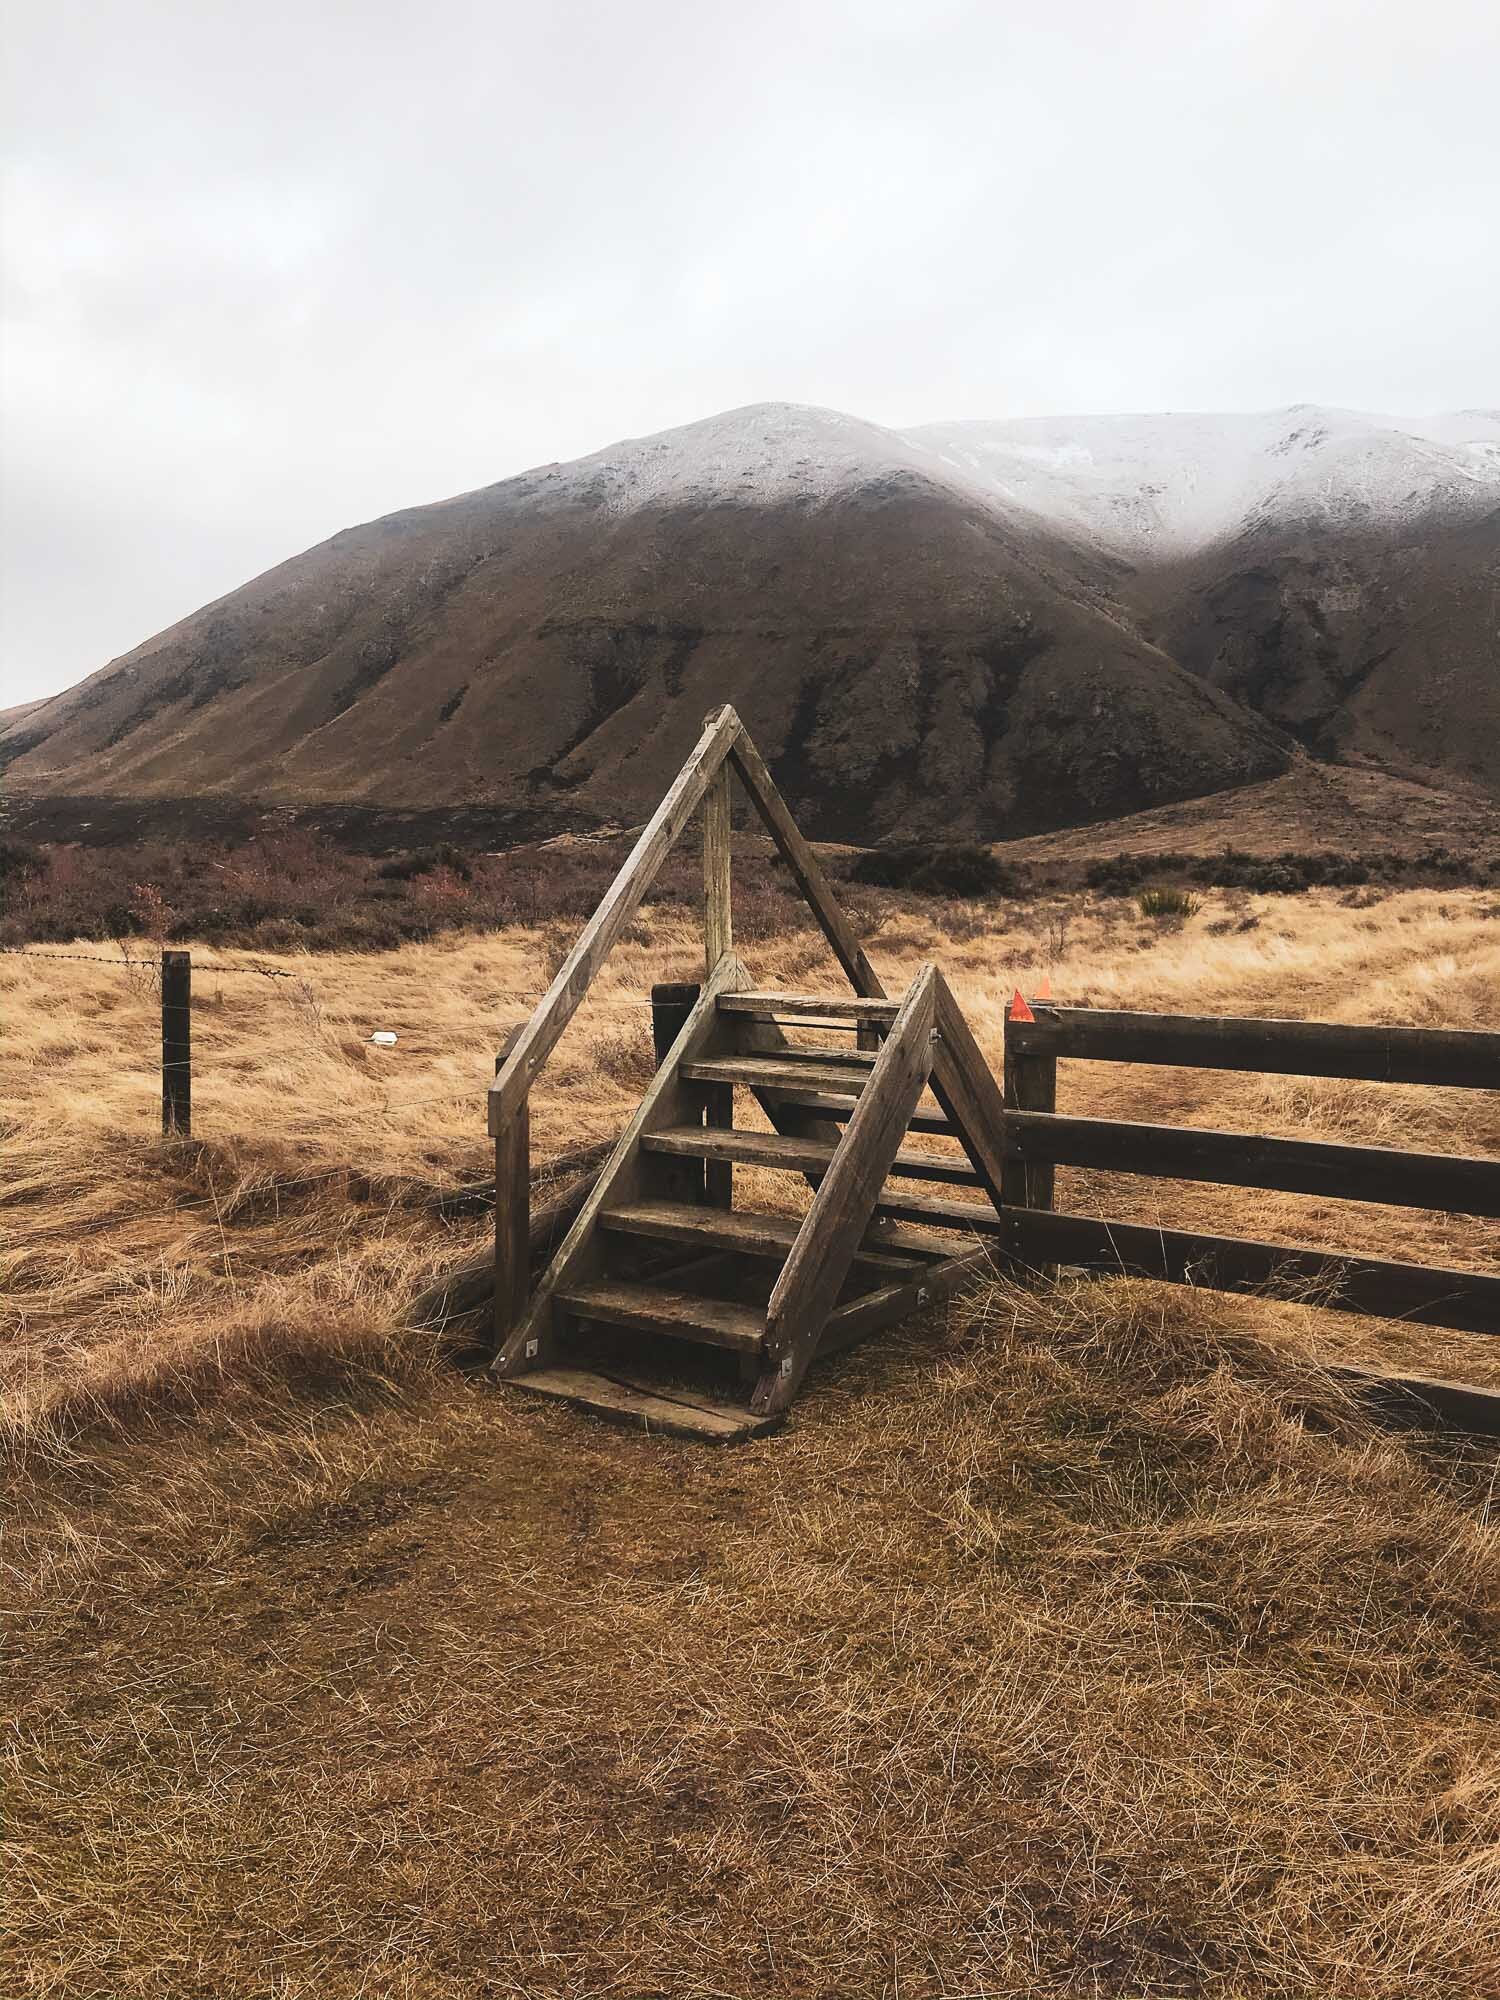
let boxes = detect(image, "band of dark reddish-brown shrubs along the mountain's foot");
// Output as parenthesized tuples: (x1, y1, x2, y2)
(0, 826, 1500, 952)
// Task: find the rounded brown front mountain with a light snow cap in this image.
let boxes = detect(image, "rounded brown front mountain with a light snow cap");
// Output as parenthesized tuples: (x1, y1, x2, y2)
(0, 408, 1286, 838)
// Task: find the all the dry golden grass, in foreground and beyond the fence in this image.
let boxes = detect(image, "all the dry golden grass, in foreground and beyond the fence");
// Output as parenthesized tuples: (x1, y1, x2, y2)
(0, 894, 1500, 2000)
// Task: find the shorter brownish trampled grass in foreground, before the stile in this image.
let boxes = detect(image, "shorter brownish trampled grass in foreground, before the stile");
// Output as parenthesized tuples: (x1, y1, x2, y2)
(8, 1282, 1500, 2000)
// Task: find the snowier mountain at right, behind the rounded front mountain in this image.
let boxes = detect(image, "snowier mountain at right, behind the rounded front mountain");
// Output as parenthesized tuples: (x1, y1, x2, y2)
(914, 408, 1500, 790)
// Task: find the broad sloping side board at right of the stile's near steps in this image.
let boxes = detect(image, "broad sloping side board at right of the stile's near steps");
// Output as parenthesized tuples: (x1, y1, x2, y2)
(750, 966, 936, 1416)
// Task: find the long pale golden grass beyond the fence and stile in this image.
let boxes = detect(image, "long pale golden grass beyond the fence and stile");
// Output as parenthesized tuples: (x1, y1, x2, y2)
(0, 892, 1500, 1440)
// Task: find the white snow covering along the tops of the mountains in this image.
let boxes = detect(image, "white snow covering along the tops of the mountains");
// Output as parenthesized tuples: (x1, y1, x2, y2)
(544, 402, 1500, 560)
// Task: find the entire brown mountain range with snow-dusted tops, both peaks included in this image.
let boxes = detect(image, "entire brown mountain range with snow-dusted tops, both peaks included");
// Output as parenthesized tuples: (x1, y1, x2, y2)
(0, 404, 1500, 840)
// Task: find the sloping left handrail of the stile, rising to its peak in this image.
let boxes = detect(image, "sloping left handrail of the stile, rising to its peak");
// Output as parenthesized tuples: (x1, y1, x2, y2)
(490, 708, 740, 1136)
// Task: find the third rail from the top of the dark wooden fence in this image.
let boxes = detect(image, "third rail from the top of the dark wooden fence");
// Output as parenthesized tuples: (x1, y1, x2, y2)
(1000, 1208, 1500, 1334)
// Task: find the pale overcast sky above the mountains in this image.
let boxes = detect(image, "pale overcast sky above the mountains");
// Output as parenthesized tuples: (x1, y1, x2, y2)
(0, 0, 1500, 704)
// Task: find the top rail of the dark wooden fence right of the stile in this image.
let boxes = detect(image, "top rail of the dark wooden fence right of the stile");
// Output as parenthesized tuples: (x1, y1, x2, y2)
(1006, 1004, 1500, 1090)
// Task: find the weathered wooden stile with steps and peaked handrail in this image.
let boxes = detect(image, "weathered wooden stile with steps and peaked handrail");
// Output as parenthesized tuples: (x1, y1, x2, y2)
(490, 708, 1002, 1438)
